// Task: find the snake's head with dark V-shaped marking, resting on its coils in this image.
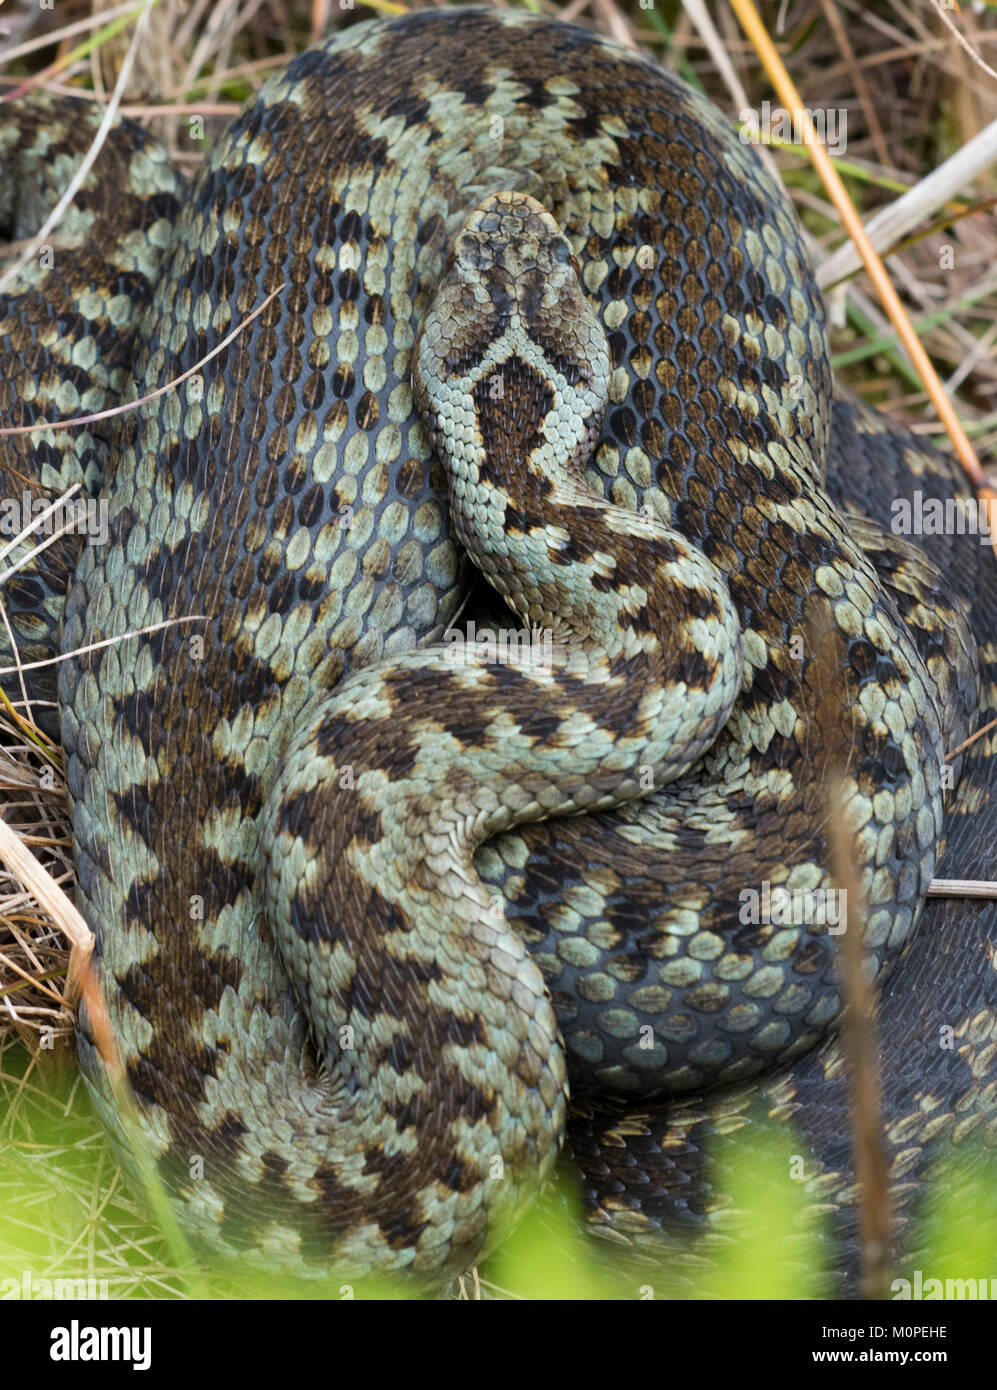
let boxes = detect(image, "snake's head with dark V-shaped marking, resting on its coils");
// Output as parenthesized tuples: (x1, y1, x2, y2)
(413, 192, 609, 522)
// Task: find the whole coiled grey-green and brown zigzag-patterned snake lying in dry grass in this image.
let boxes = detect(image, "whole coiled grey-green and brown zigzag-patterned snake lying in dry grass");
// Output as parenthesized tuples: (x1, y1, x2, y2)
(0, 8, 997, 1287)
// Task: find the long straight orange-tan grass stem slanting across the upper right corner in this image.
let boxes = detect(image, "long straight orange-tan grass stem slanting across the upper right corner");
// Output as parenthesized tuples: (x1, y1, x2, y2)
(730, 0, 997, 546)
